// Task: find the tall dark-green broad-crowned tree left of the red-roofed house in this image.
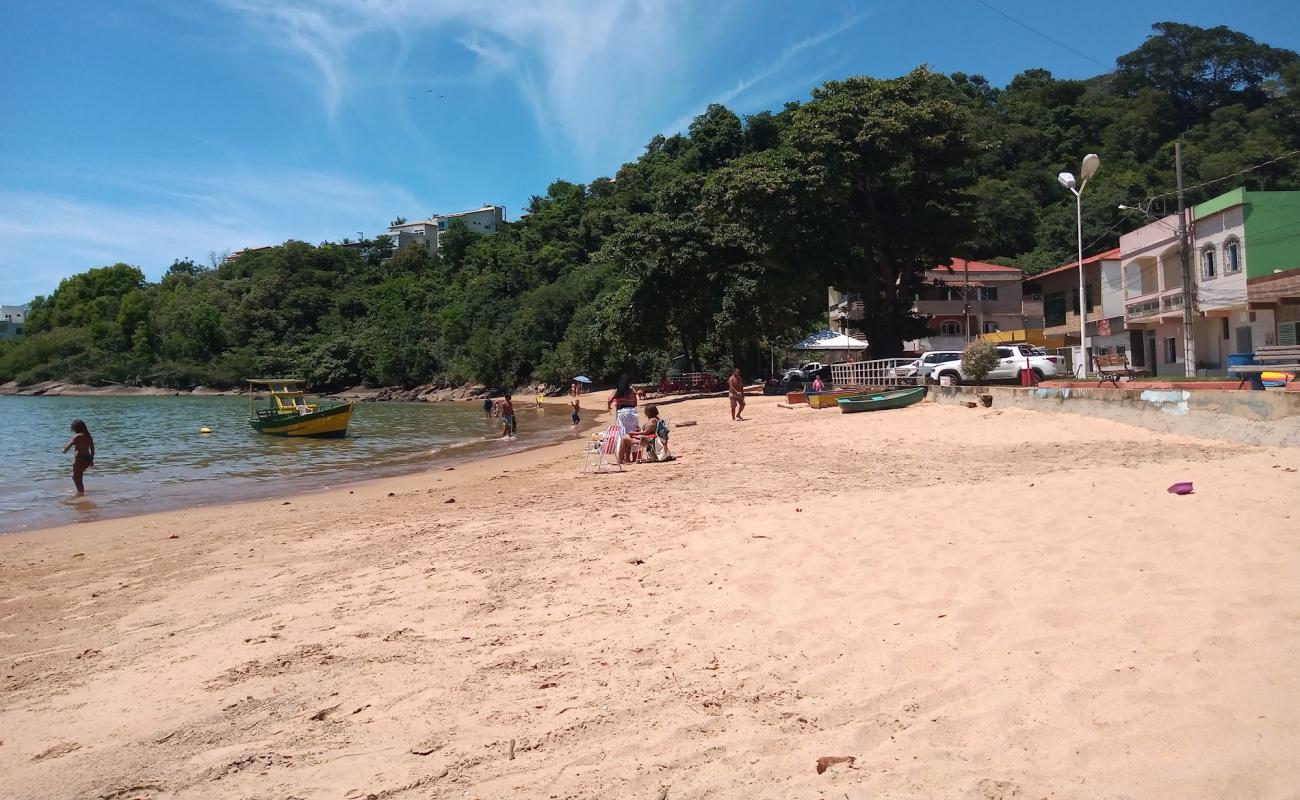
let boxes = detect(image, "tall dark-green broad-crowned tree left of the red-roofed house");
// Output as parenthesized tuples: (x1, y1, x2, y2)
(789, 68, 975, 356)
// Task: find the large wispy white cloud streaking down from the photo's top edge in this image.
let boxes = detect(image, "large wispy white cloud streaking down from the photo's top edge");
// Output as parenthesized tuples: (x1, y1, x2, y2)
(213, 0, 698, 169)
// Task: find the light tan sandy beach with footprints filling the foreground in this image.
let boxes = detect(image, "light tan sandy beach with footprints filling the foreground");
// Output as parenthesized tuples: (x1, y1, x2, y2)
(0, 398, 1300, 800)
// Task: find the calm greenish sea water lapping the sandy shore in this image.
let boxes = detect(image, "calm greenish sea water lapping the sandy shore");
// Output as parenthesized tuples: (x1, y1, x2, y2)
(0, 397, 572, 532)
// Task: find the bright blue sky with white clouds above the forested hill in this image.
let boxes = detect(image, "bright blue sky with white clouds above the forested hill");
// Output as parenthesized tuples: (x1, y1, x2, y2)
(0, 0, 1300, 303)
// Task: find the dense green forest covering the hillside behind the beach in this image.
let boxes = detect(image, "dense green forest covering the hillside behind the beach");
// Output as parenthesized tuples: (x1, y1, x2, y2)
(0, 22, 1300, 389)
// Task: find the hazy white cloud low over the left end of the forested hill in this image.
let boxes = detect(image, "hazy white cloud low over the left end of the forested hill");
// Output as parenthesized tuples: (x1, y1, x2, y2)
(0, 169, 425, 303)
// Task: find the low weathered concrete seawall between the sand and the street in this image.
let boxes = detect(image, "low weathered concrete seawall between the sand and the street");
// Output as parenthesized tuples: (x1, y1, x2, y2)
(930, 386, 1300, 447)
